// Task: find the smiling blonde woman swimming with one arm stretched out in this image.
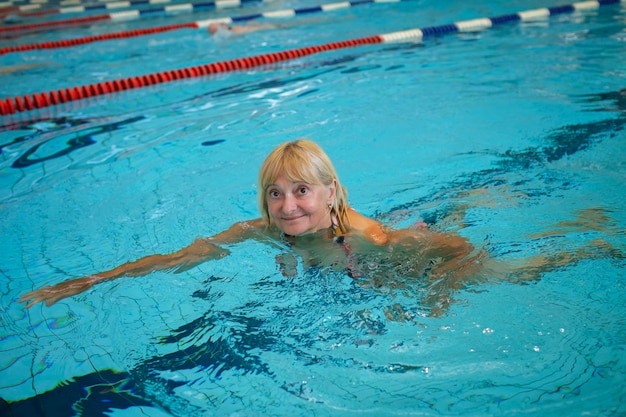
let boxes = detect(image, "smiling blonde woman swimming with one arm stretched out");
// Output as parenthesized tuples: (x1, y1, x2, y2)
(20, 139, 477, 308)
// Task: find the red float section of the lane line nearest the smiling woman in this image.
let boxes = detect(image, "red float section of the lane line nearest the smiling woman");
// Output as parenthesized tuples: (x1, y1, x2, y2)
(0, 35, 384, 115)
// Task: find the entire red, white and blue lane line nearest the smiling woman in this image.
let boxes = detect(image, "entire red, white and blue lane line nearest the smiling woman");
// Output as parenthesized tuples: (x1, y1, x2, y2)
(0, 0, 626, 115)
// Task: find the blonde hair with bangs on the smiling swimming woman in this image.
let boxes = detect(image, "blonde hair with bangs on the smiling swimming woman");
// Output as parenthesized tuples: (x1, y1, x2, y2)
(258, 139, 348, 233)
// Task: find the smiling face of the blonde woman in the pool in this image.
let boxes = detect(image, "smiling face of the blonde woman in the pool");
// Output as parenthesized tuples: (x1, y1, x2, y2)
(265, 175, 336, 236)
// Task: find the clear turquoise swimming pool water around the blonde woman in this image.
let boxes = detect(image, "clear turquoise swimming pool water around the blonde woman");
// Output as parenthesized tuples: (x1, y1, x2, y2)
(0, 1, 626, 416)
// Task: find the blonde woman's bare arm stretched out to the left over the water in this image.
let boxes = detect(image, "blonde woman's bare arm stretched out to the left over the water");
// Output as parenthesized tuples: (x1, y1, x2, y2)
(19, 219, 263, 308)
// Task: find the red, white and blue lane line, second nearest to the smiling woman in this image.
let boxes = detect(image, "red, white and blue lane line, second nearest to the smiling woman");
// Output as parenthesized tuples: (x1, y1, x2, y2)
(0, 0, 400, 55)
